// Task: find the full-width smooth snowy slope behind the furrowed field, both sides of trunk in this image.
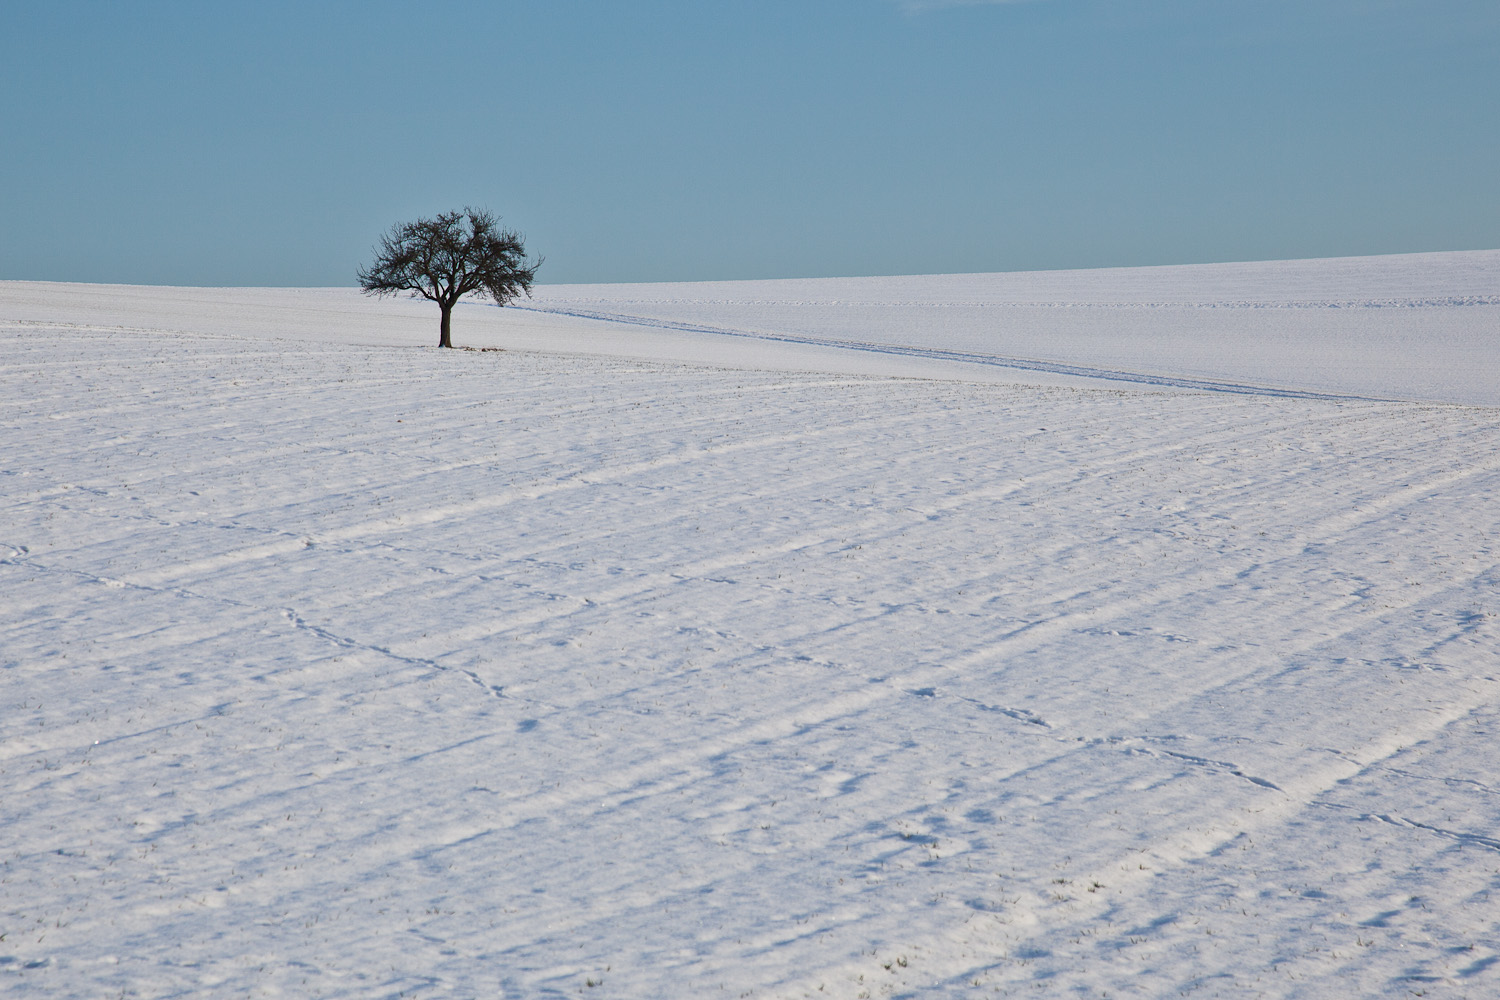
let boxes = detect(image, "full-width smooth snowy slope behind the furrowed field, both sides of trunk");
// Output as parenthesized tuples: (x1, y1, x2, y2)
(0, 250, 1500, 405)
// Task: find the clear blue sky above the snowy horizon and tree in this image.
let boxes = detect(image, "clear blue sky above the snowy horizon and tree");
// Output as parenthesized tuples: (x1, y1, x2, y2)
(0, 0, 1500, 285)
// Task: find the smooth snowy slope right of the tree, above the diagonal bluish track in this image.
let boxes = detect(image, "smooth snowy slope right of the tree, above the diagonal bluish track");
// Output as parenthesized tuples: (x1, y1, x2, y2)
(522, 250, 1500, 405)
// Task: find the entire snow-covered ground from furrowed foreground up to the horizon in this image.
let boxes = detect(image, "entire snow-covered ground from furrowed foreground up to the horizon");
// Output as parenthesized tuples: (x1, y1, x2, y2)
(0, 252, 1500, 999)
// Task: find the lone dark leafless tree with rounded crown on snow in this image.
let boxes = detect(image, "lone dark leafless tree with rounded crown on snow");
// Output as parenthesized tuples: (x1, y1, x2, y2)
(359, 208, 542, 348)
